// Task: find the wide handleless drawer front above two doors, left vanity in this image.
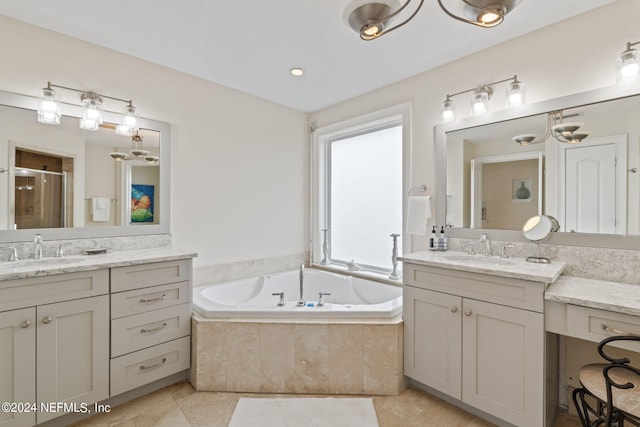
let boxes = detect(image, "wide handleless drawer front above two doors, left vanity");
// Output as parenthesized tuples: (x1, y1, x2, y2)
(0, 269, 109, 311)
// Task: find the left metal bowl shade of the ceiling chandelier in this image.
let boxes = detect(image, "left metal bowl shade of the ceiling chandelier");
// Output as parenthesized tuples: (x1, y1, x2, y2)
(344, 0, 424, 41)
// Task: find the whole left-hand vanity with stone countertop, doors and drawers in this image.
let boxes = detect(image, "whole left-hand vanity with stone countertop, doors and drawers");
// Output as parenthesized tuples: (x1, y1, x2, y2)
(0, 249, 195, 426)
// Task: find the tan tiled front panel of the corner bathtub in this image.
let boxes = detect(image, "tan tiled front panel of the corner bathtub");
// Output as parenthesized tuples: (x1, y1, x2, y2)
(191, 314, 405, 395)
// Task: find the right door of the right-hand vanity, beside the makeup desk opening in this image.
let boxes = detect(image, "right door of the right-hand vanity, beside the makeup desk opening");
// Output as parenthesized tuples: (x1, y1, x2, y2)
(462, 299, 545, 427)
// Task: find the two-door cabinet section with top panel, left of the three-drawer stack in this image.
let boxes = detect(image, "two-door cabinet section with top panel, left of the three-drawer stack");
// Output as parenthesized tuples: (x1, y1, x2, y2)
(0, 270, 109, 427)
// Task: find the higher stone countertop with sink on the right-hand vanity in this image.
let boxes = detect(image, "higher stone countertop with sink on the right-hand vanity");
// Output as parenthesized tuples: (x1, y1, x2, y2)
(398, 251, 565, 283)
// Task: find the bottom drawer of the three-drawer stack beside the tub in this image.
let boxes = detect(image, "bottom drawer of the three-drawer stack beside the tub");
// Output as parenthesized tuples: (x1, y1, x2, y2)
(111, 337, 191, 396)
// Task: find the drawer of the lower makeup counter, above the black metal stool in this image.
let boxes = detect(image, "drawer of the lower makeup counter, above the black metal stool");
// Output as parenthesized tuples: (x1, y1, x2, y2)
(567, 304, 640, 352)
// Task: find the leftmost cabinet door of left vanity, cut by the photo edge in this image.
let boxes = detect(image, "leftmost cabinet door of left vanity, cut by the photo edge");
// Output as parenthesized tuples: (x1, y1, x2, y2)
(0, 308, 36, 427)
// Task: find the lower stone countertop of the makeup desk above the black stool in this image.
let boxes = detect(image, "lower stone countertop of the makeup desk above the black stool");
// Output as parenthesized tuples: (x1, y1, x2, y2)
(544, 276, 640, 316)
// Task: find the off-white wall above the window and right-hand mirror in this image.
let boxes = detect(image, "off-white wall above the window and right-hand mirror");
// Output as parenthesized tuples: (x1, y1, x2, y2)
(311, 0, 640, 254)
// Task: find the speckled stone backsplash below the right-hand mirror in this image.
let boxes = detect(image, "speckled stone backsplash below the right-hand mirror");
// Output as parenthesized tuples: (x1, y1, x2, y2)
(449, 236, 640, 285)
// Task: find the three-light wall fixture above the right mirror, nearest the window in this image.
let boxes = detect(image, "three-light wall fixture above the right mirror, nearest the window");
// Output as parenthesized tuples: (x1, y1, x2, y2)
(442, 75, 525, 122)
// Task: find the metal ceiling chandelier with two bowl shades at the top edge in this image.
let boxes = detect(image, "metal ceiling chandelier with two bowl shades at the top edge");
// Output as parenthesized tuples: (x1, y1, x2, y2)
(344, 0, 518, 41)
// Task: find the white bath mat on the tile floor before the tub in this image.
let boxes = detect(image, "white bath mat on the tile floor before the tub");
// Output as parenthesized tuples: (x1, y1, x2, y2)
(229, 397, 379, 427)
